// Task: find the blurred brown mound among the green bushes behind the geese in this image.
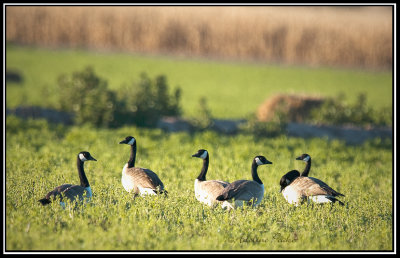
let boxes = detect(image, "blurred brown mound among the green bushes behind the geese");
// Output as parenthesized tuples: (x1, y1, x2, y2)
(257, 94, 324, 122)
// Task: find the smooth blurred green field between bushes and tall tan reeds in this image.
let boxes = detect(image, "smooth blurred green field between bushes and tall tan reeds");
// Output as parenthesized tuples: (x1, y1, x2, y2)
(6, 45, 392, 118)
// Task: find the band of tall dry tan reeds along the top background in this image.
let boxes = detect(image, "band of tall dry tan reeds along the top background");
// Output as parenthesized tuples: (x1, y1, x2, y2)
(6, 6, 393, 69)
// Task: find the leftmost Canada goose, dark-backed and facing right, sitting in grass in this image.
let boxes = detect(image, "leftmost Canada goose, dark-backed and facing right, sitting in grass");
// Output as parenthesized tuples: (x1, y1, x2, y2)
(39, 151, 97, 207)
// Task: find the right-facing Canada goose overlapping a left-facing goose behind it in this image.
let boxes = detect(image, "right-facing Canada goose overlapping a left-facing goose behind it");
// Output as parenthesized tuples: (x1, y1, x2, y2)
(217, 156, 272, 209)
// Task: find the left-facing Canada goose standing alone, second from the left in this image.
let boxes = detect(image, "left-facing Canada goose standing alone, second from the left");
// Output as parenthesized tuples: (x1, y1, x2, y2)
(120, 136, 167, 196)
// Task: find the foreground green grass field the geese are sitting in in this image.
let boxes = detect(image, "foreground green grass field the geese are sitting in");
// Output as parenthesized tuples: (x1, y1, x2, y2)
(5, 116, 393, 251)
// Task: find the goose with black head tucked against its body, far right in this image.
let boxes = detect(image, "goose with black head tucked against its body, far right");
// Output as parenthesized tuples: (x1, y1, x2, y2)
(279, 167, 344, 206)
